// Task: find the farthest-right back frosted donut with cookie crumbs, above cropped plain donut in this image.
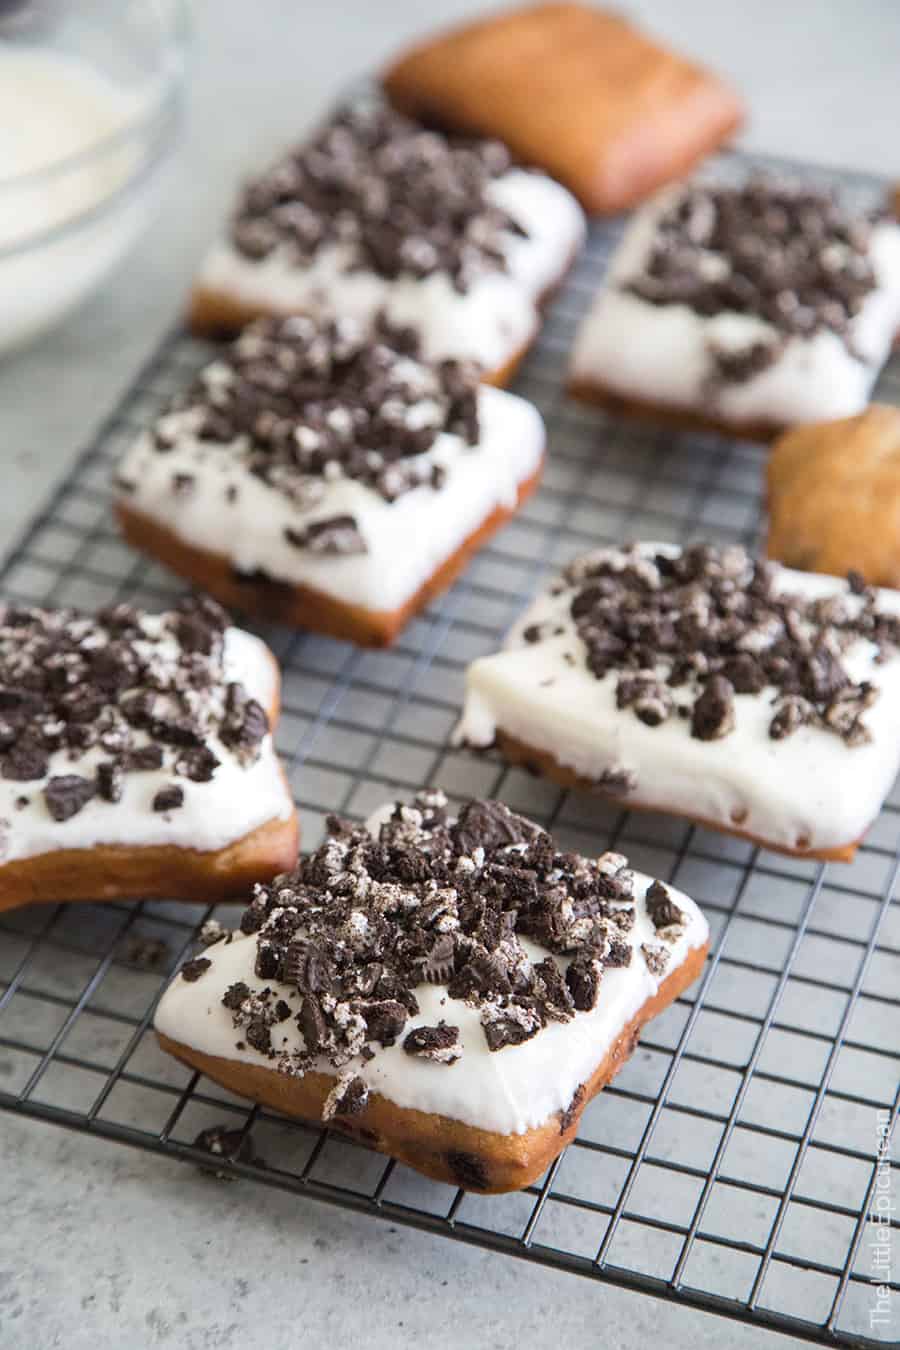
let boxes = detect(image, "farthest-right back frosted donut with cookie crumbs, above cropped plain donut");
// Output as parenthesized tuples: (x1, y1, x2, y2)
(569, 174, 900, 440)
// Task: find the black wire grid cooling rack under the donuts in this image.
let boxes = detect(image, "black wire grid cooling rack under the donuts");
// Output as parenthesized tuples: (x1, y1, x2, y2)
(0, 157, 900, 1346)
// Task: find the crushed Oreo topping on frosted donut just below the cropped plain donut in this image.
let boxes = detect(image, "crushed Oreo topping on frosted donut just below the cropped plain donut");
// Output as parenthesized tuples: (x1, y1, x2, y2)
(559, 544, 900, 750)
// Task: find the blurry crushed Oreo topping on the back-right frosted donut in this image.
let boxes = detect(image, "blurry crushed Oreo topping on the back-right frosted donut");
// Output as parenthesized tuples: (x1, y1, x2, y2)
(622, 174, 876, 385)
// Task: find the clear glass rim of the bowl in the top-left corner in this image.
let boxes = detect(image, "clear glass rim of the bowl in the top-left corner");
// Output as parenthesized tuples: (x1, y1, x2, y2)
(0, 0, 189, 262)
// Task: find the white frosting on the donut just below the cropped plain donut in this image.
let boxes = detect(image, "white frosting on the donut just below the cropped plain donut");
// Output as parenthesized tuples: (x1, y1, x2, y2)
(455, 544, 900, 849)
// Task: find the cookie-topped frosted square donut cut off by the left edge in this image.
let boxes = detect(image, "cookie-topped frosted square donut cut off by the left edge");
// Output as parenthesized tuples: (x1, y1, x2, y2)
(0, 599, 297, 910)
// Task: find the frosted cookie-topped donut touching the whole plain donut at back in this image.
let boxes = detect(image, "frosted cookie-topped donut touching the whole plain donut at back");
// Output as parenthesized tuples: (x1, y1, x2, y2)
(190, 97, 584, 385)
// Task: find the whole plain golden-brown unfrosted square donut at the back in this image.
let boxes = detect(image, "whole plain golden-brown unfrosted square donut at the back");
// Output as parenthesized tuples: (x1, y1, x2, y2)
(383, 4, 743, 215)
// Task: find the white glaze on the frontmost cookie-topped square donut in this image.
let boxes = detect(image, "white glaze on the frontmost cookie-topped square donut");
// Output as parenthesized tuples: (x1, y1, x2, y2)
(155, 807, 708, 1134)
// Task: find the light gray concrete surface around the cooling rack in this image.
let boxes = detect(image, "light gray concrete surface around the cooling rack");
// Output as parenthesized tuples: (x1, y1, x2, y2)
(0, 0, 900, 1350)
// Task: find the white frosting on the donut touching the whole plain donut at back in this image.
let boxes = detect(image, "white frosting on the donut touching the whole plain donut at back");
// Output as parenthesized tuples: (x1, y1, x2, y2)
(200, 169, 584, 370)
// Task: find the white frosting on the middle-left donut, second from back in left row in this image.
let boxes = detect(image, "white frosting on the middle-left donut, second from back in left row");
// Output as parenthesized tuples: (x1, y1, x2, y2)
(120, 386, 544, 612)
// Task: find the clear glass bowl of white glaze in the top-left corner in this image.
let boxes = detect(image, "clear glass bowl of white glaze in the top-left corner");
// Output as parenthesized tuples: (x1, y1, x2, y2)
(0, 0, 186, 352)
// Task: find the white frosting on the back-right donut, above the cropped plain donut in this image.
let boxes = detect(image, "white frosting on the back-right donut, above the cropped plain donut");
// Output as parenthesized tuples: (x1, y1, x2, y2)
(569, 189, 900, 425)
